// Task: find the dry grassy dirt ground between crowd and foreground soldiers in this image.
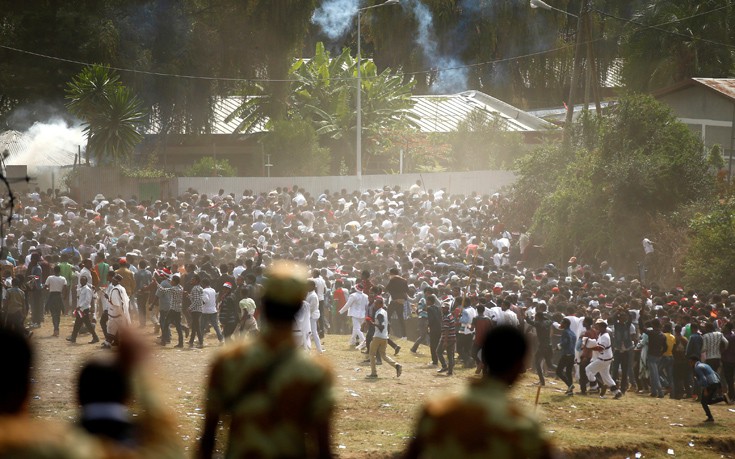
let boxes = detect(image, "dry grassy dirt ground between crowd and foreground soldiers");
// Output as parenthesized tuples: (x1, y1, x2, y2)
(25, 317, 735, 458)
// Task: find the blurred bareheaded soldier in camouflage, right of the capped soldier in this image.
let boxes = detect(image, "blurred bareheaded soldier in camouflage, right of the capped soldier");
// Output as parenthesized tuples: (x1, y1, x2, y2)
(405, 326, 551, 459)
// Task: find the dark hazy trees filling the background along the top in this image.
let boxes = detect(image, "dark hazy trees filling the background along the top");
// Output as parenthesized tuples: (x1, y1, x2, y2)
(5, 0, 735, 133)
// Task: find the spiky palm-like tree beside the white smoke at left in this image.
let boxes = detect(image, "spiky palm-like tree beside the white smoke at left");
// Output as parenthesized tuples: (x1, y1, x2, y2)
(66, 65, 146, 163)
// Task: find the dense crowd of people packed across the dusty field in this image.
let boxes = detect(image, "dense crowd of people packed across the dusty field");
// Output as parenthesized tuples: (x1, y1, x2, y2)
(0, 182, 735, 456)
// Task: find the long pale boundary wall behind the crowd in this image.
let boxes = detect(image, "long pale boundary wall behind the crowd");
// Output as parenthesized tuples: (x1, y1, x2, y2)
(178, 171, 515, 196)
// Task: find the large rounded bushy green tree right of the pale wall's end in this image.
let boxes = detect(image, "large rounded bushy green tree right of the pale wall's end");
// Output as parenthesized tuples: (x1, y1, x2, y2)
(513, 96, 714, 268)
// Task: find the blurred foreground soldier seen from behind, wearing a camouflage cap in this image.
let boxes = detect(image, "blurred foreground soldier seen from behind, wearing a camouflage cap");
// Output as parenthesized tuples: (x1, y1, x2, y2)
(198, 262, 334, 458)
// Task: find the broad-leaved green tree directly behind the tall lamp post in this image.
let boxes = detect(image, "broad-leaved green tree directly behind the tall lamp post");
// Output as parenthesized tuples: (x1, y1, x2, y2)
(227, 42, 416, 174)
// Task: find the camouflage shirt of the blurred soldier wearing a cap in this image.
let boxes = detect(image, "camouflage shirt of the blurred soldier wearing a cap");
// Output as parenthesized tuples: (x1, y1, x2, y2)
(207, 331, 334, 459)
